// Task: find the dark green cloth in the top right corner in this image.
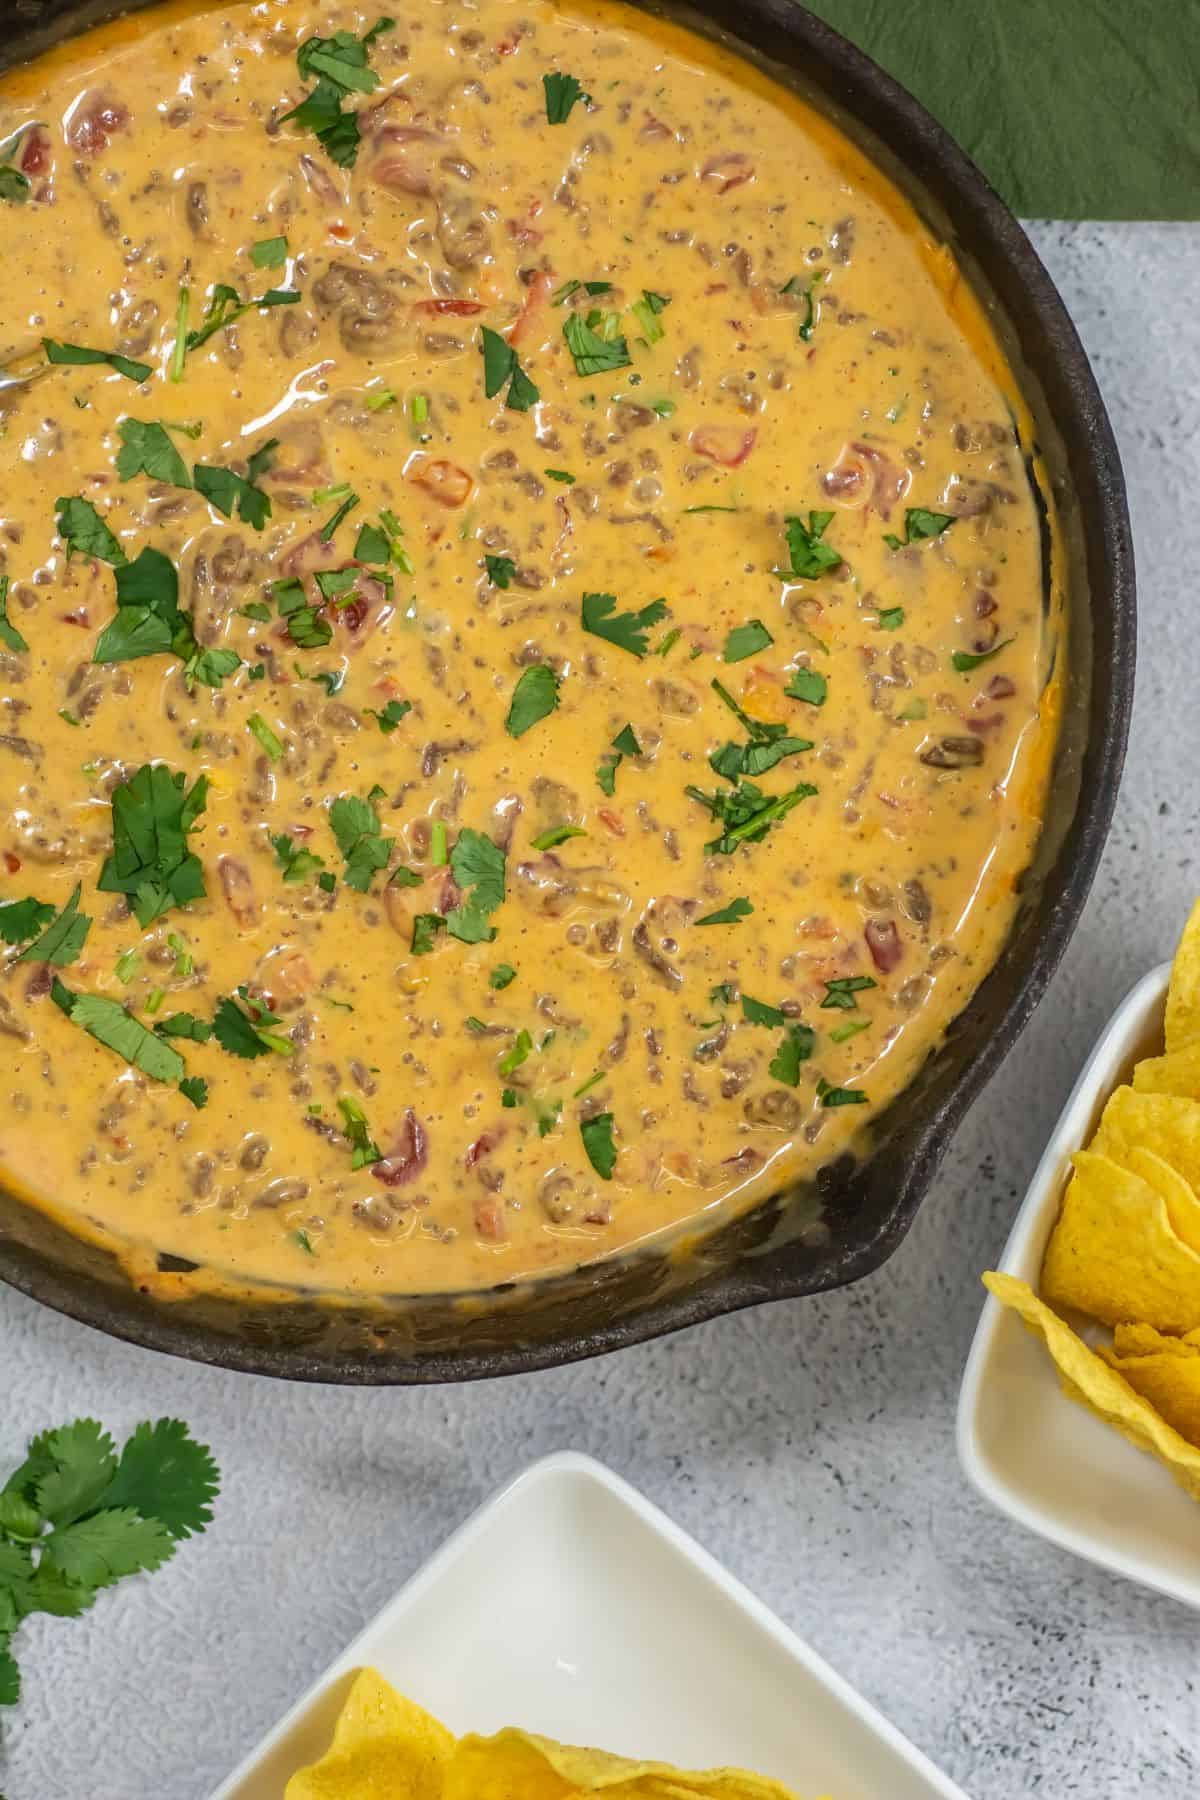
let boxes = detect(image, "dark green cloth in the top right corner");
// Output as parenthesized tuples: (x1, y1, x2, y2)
(806, 0, 1200, 217)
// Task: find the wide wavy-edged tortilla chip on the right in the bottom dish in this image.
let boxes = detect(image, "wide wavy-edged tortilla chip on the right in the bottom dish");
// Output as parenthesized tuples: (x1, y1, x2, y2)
(444, 1730, 795, 1800)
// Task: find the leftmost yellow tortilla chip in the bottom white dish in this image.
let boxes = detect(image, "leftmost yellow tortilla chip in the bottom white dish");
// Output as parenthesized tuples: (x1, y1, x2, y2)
(284, 1669, 453, 1800)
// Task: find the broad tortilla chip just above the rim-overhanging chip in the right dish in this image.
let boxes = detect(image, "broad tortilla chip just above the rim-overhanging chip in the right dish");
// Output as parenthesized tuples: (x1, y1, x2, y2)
(1042, 1150, 1200, 1332)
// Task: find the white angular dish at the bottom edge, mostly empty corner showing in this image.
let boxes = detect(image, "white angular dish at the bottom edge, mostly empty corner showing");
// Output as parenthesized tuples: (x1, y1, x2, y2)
(212, 1454, 966, 1800)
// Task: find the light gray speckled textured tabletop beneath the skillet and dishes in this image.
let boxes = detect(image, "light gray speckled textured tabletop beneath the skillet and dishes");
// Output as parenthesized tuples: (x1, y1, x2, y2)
(0, 225, 1200, 1800)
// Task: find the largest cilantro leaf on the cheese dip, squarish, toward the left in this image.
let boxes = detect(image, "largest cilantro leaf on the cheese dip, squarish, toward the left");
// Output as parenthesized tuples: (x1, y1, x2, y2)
(97, 763, 209, 929)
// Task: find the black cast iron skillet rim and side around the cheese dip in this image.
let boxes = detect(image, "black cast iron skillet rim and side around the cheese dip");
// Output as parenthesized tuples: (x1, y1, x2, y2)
(0, 0, 1135, 1384)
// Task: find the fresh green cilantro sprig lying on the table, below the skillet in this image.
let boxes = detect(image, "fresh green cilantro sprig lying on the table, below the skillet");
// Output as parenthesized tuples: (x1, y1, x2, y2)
(0, 1418, 219, 1706)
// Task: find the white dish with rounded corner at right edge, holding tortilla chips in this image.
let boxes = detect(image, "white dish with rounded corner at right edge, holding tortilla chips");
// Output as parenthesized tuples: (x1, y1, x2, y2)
(959, 963, 1200, 1607)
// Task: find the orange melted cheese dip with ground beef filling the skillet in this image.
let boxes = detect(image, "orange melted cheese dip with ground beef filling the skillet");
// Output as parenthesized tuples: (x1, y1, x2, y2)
(0, 0, 1054, 1292)
